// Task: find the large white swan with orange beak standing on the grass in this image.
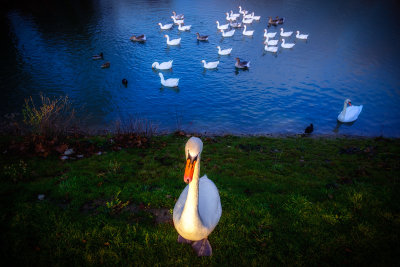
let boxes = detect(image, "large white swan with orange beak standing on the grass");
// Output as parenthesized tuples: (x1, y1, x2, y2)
(173, 137, 222, 256)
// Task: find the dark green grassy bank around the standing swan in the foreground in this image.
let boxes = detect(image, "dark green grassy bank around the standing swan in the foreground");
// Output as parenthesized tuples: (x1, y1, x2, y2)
(0, 136, 400, 266)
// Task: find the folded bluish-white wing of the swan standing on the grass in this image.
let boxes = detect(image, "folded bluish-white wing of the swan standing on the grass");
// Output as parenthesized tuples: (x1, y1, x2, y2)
(199, 175, 222, 229)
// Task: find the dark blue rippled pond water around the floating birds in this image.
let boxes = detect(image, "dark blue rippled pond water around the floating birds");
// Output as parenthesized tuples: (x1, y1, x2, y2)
(0, 0, 400, 137)
